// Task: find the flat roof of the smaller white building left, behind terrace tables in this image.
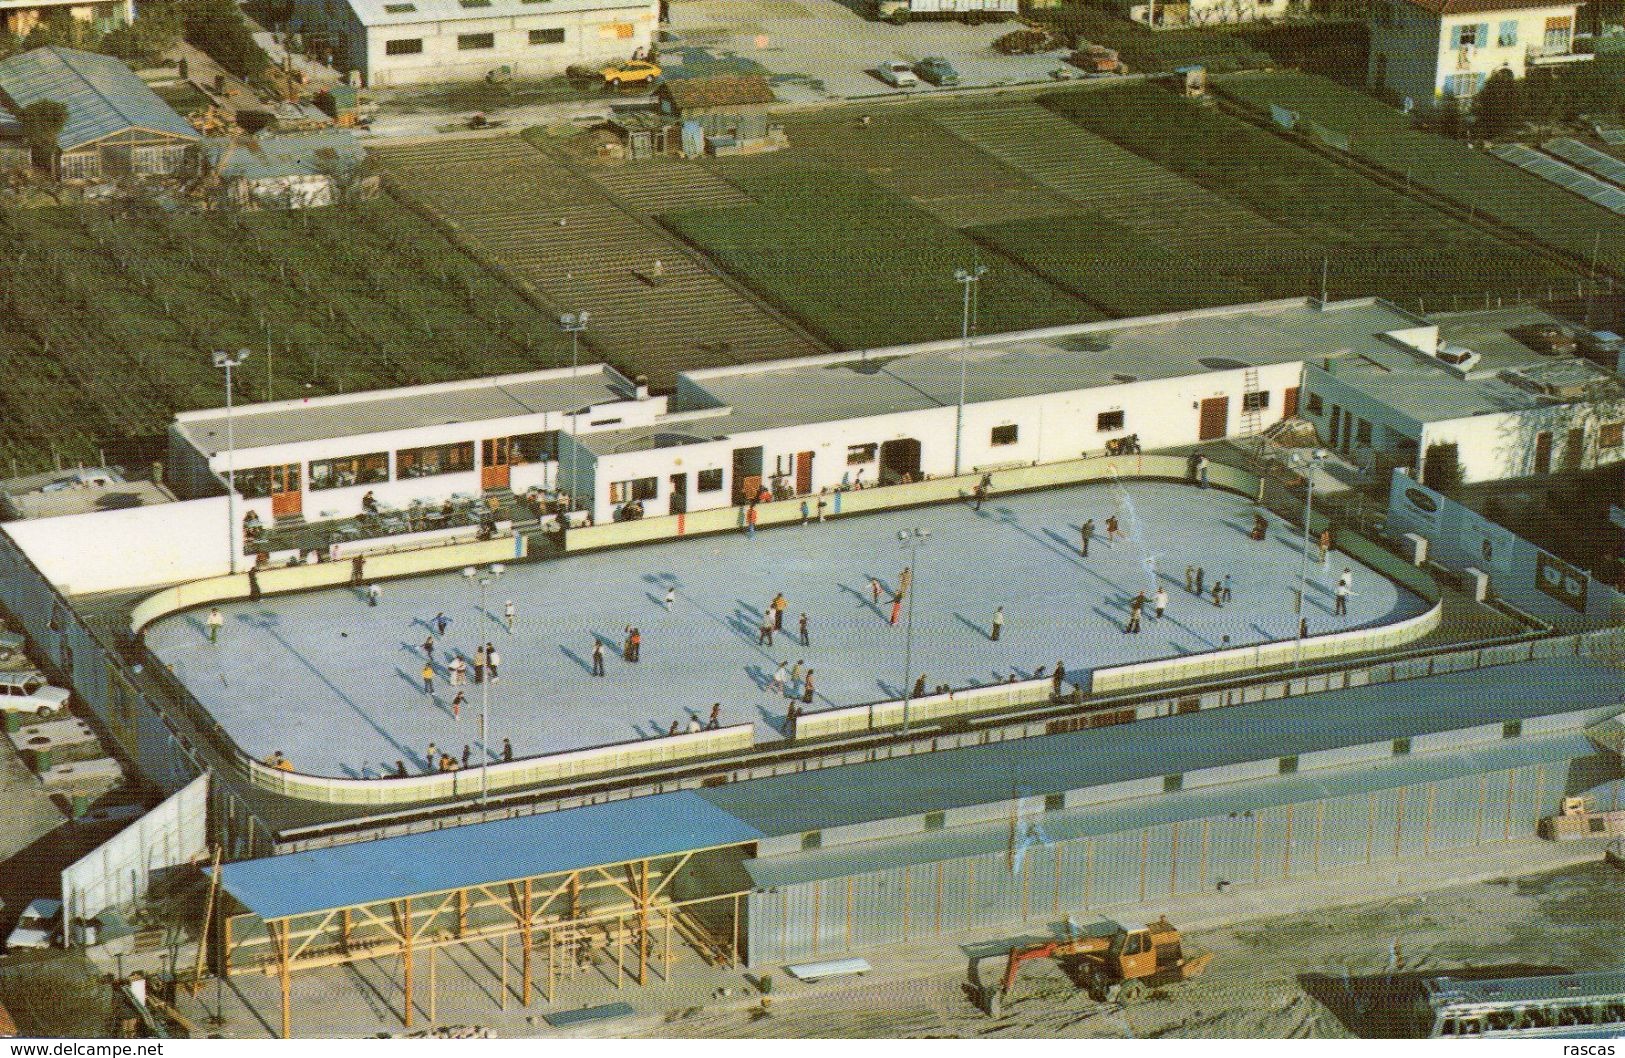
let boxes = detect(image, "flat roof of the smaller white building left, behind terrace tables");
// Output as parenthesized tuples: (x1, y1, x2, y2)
(176, 364, 631, 455)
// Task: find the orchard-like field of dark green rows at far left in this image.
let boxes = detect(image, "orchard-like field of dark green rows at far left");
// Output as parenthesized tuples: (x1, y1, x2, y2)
(0, 198, 569, 473)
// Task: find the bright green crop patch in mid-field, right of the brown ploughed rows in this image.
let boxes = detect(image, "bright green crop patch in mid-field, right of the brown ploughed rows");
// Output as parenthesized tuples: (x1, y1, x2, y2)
(665, 158, 1103, 349)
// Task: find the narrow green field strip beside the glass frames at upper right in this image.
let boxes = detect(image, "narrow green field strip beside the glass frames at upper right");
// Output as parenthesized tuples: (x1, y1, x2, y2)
(1219, 73, 1625, 270)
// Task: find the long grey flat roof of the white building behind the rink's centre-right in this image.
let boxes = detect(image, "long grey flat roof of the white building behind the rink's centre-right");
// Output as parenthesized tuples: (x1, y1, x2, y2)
(582, 299, 1423, 455)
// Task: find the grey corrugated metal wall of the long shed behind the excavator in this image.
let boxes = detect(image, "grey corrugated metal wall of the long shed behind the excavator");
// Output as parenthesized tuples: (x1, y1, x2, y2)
(749, 764, 1622, 965)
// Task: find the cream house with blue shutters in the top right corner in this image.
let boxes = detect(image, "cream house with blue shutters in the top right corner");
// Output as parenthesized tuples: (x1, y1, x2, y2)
(1368, 0, 1591, 106)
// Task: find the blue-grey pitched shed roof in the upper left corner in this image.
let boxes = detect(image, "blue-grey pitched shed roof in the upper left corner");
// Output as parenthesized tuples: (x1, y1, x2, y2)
(0, 47, 198, 151)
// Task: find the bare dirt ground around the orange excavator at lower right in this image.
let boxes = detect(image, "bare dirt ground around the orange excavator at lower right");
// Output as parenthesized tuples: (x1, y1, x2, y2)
(647, 861, 1625, 1038)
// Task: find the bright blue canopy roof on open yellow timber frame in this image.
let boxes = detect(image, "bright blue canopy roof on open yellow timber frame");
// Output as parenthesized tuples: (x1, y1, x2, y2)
(221, 790, 762, 920)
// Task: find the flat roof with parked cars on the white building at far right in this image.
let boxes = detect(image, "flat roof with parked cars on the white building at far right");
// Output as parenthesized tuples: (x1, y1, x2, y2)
(1311, 306, 1625, 423)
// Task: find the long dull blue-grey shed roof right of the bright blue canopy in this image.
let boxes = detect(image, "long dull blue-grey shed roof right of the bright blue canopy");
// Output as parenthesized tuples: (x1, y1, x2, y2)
(702, 658, 1625, 835)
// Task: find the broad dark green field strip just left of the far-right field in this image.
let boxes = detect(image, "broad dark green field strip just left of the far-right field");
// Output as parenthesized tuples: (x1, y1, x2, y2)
(1043, 85, 1573, 306)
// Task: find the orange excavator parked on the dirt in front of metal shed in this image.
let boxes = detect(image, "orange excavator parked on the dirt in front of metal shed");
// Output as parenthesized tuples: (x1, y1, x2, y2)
(982, 917, 1212, 1017)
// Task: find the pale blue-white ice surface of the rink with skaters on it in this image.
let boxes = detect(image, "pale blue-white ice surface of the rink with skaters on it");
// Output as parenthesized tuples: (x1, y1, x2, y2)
(146, 481, 1424, 777)
